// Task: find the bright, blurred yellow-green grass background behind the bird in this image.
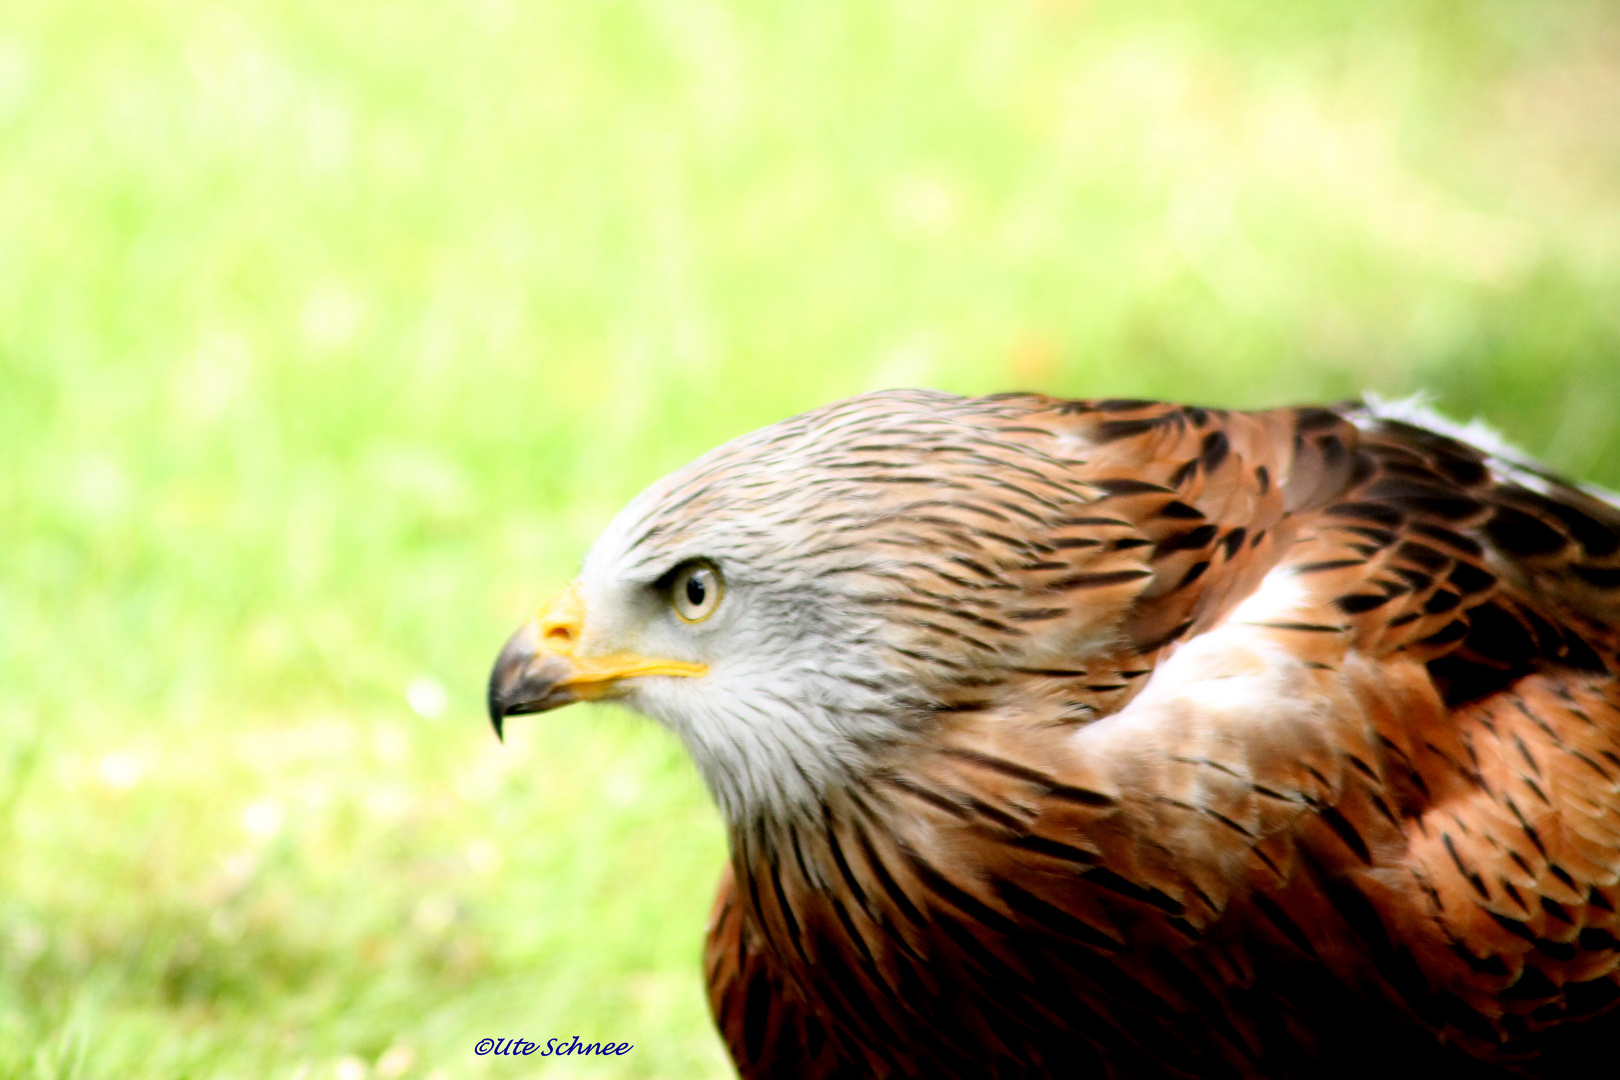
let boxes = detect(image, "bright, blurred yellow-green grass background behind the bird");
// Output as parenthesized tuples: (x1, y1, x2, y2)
(0, 0, 1620, 1080)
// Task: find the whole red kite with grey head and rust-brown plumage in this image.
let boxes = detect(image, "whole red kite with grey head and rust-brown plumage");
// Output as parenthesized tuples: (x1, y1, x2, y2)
(489, 390, 1620, 1080)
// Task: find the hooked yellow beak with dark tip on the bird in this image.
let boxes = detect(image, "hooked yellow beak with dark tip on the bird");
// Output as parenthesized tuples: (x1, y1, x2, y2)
(489, 583, 708, 738)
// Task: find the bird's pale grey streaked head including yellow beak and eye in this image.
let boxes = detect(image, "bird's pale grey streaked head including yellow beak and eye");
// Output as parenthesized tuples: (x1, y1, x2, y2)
(489, 390, 1147, 821)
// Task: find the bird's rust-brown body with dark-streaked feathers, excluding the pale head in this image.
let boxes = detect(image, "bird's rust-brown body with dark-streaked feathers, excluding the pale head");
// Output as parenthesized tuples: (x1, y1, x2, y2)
(710, 397, 1620, 1077)
